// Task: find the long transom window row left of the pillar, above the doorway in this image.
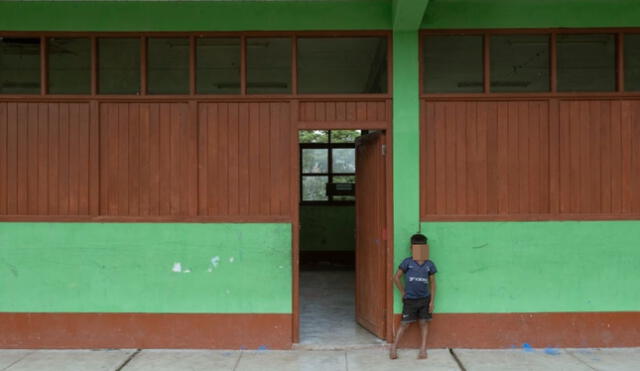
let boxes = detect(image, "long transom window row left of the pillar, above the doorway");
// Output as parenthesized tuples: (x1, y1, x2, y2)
(0, 32, 389, 96)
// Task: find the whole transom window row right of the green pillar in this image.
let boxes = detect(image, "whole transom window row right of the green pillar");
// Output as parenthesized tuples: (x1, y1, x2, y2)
(422, 31, 640, 94)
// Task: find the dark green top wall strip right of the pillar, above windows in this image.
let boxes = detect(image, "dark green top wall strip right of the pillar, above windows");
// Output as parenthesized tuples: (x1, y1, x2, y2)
(422, 0, 640, 29)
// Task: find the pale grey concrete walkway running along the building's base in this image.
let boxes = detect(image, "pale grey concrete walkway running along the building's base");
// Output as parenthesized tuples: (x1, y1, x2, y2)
(0, 347, 640, 371)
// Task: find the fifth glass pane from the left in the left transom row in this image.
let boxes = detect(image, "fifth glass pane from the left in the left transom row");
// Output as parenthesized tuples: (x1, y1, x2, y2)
(196, 37, 240, 94)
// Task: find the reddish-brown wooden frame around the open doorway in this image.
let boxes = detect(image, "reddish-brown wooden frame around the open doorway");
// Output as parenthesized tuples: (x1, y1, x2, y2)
(291, 117, 394, 343)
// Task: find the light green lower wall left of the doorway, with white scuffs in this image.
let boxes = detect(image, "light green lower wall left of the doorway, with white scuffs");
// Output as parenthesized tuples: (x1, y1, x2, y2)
(0, 223, 291, 313)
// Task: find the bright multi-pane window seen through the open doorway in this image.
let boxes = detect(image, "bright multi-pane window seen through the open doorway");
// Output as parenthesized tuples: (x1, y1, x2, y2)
(299, 130, 360, 203)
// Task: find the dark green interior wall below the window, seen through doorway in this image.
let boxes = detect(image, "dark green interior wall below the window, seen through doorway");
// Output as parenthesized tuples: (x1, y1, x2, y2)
(300, 205, 356, 251)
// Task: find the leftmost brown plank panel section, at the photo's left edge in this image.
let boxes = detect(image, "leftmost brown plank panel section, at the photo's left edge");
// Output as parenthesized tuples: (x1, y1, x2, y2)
(0, 102, 90, 215)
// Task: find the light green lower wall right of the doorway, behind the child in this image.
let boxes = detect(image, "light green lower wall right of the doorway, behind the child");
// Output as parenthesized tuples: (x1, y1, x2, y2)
(396, 221, 640, 313)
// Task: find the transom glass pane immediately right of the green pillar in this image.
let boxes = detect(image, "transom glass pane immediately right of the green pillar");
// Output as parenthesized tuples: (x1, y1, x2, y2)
(423, 35, 483, 93)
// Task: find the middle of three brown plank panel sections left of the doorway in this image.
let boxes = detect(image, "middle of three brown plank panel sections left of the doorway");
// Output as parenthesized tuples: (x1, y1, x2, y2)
(100, 103, 197, 216)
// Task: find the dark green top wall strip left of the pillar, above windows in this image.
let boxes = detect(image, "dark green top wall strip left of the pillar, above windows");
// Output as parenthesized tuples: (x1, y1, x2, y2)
(0, 0, 391, 31)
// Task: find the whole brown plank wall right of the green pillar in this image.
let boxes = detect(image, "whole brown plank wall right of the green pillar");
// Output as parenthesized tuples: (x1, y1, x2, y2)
(421, 99, 640, 220)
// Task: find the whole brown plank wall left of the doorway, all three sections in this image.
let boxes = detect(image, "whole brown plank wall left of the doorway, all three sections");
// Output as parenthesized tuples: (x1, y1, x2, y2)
(0, 101, 295, 221)
